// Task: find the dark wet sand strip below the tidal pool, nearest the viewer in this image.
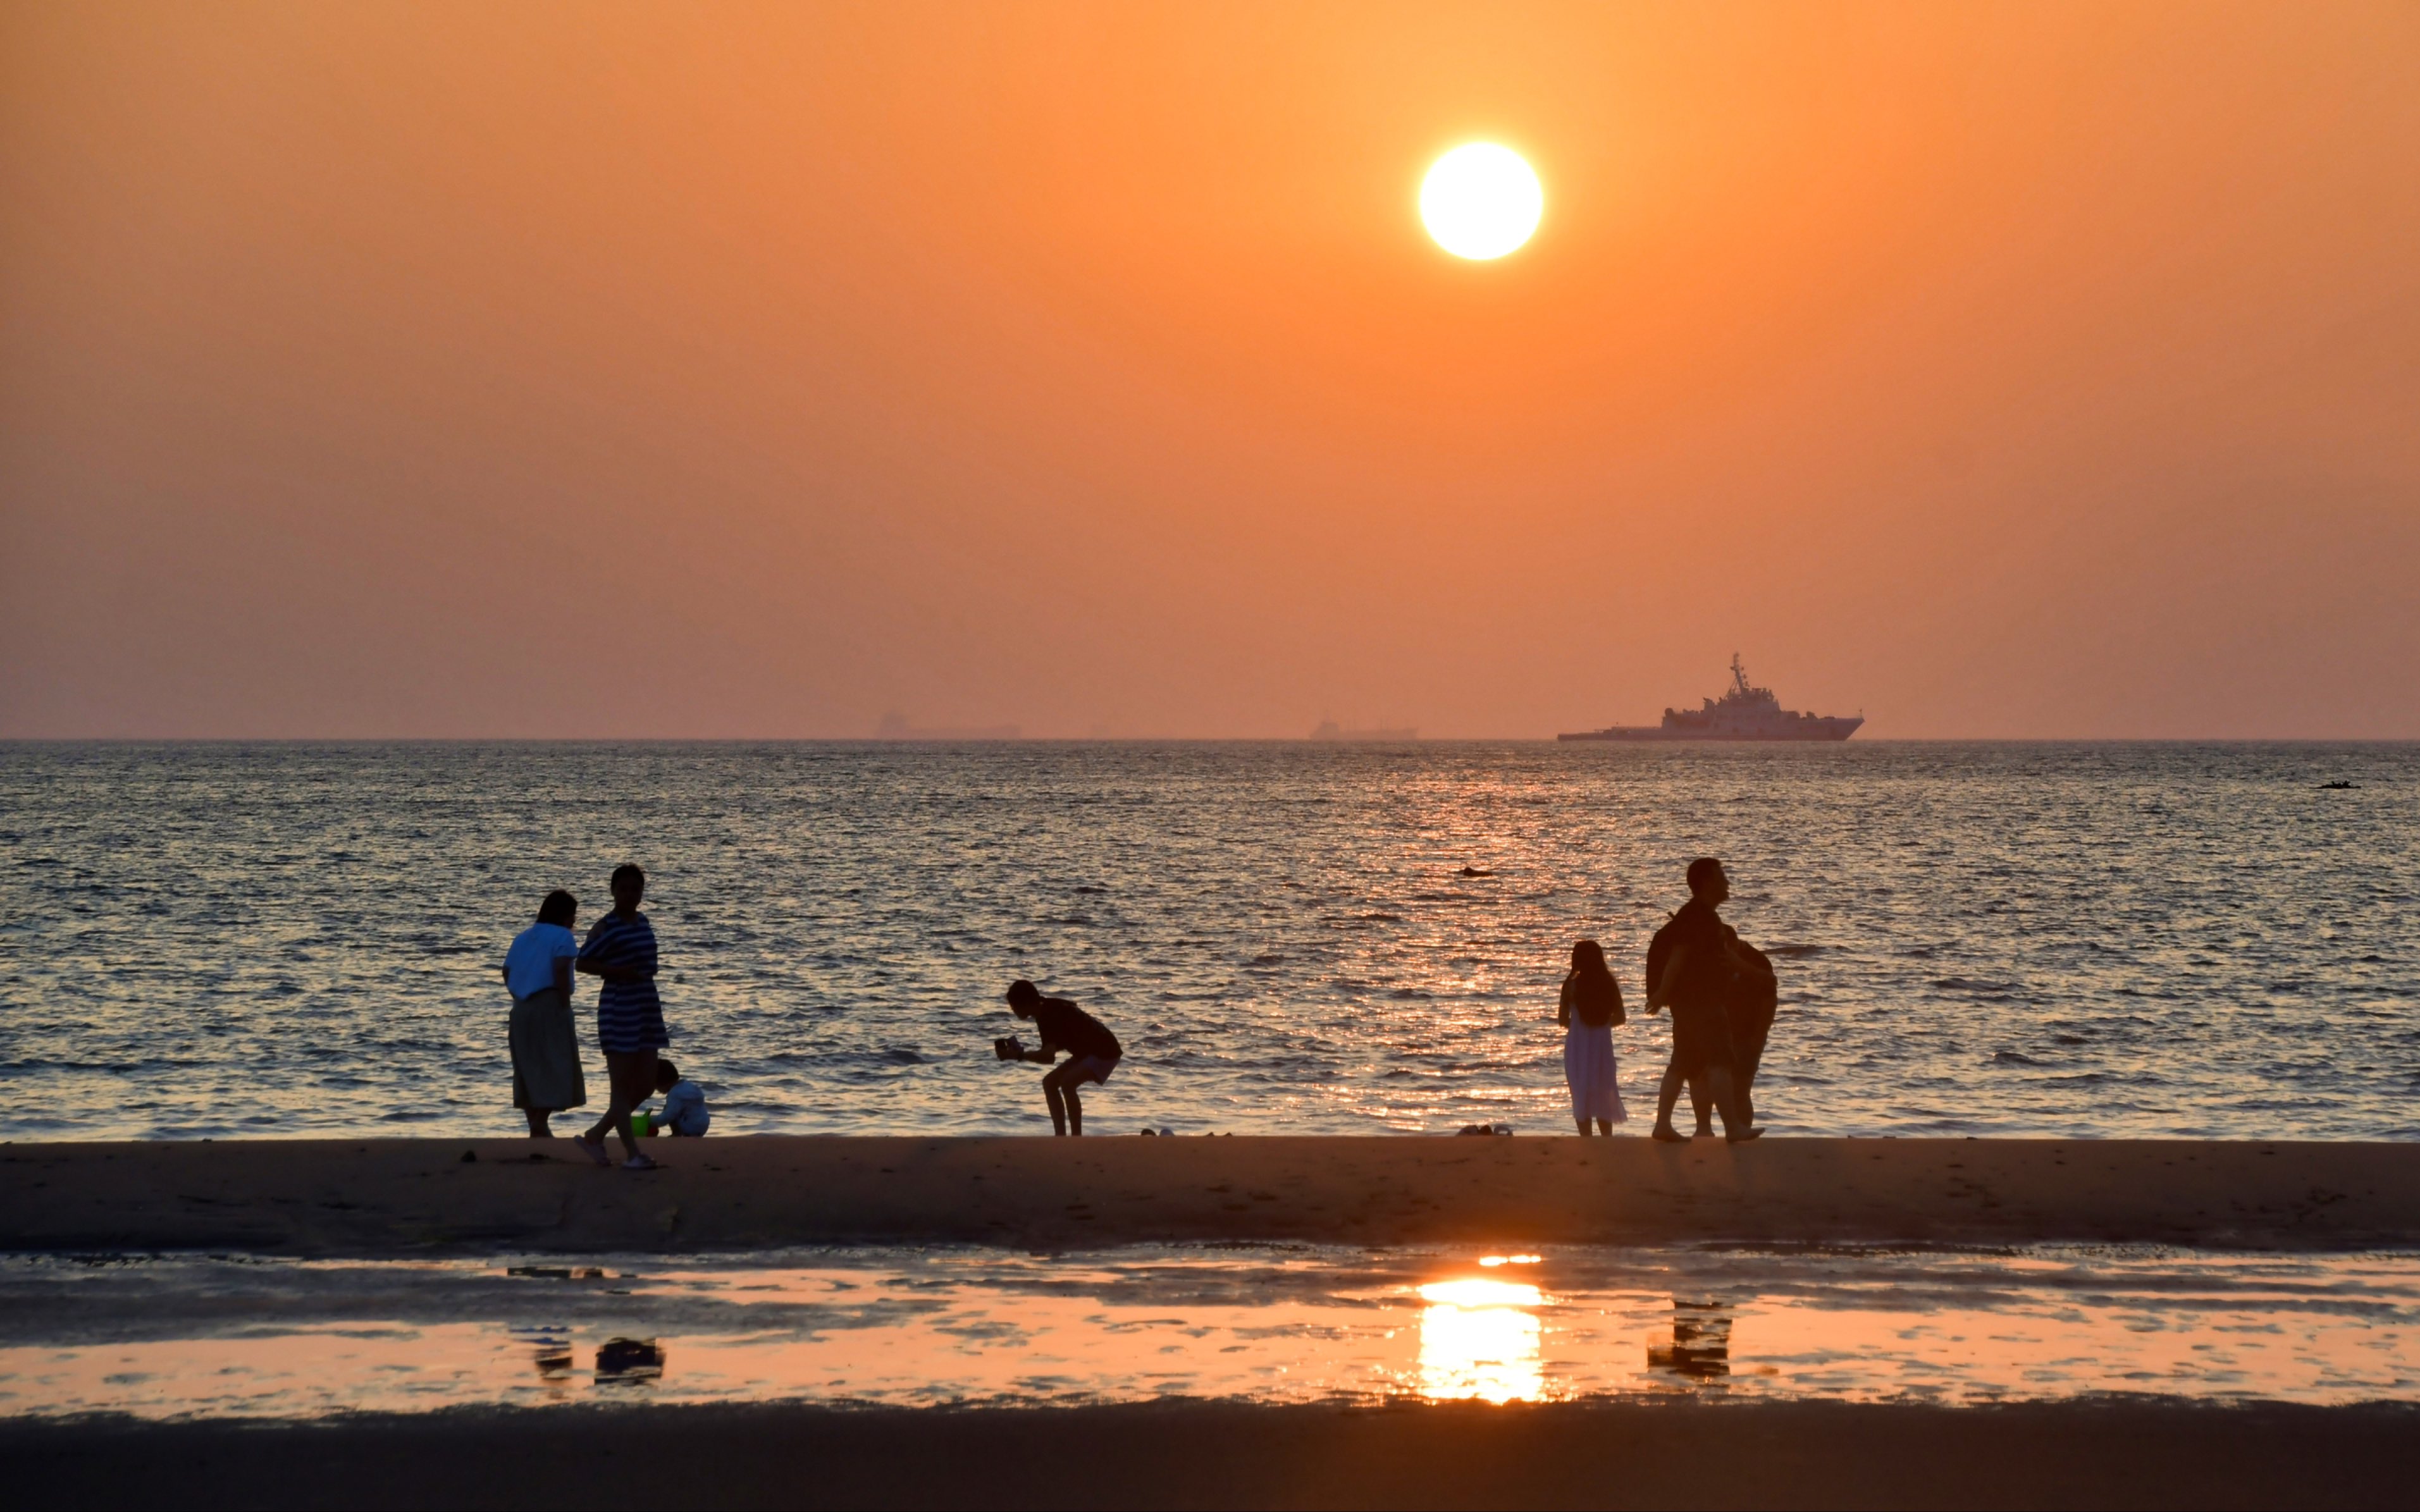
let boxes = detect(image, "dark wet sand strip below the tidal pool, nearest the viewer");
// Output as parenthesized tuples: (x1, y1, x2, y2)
(14, 1401, 2420, 1507)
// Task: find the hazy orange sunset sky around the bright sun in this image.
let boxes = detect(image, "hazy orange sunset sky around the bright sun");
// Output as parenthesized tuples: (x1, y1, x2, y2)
(0, 0, 2420, 738)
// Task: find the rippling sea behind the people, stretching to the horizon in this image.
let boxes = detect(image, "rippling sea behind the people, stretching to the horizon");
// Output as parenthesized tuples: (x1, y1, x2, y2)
(0, 742, 2420, 1137)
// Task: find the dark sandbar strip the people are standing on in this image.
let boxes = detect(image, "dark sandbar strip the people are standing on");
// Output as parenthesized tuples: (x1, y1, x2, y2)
(0, 1134, 2420, 1255)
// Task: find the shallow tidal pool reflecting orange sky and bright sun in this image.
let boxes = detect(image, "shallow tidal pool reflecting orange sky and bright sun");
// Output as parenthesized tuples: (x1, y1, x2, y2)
(0, 1246, 2420, 1418)
